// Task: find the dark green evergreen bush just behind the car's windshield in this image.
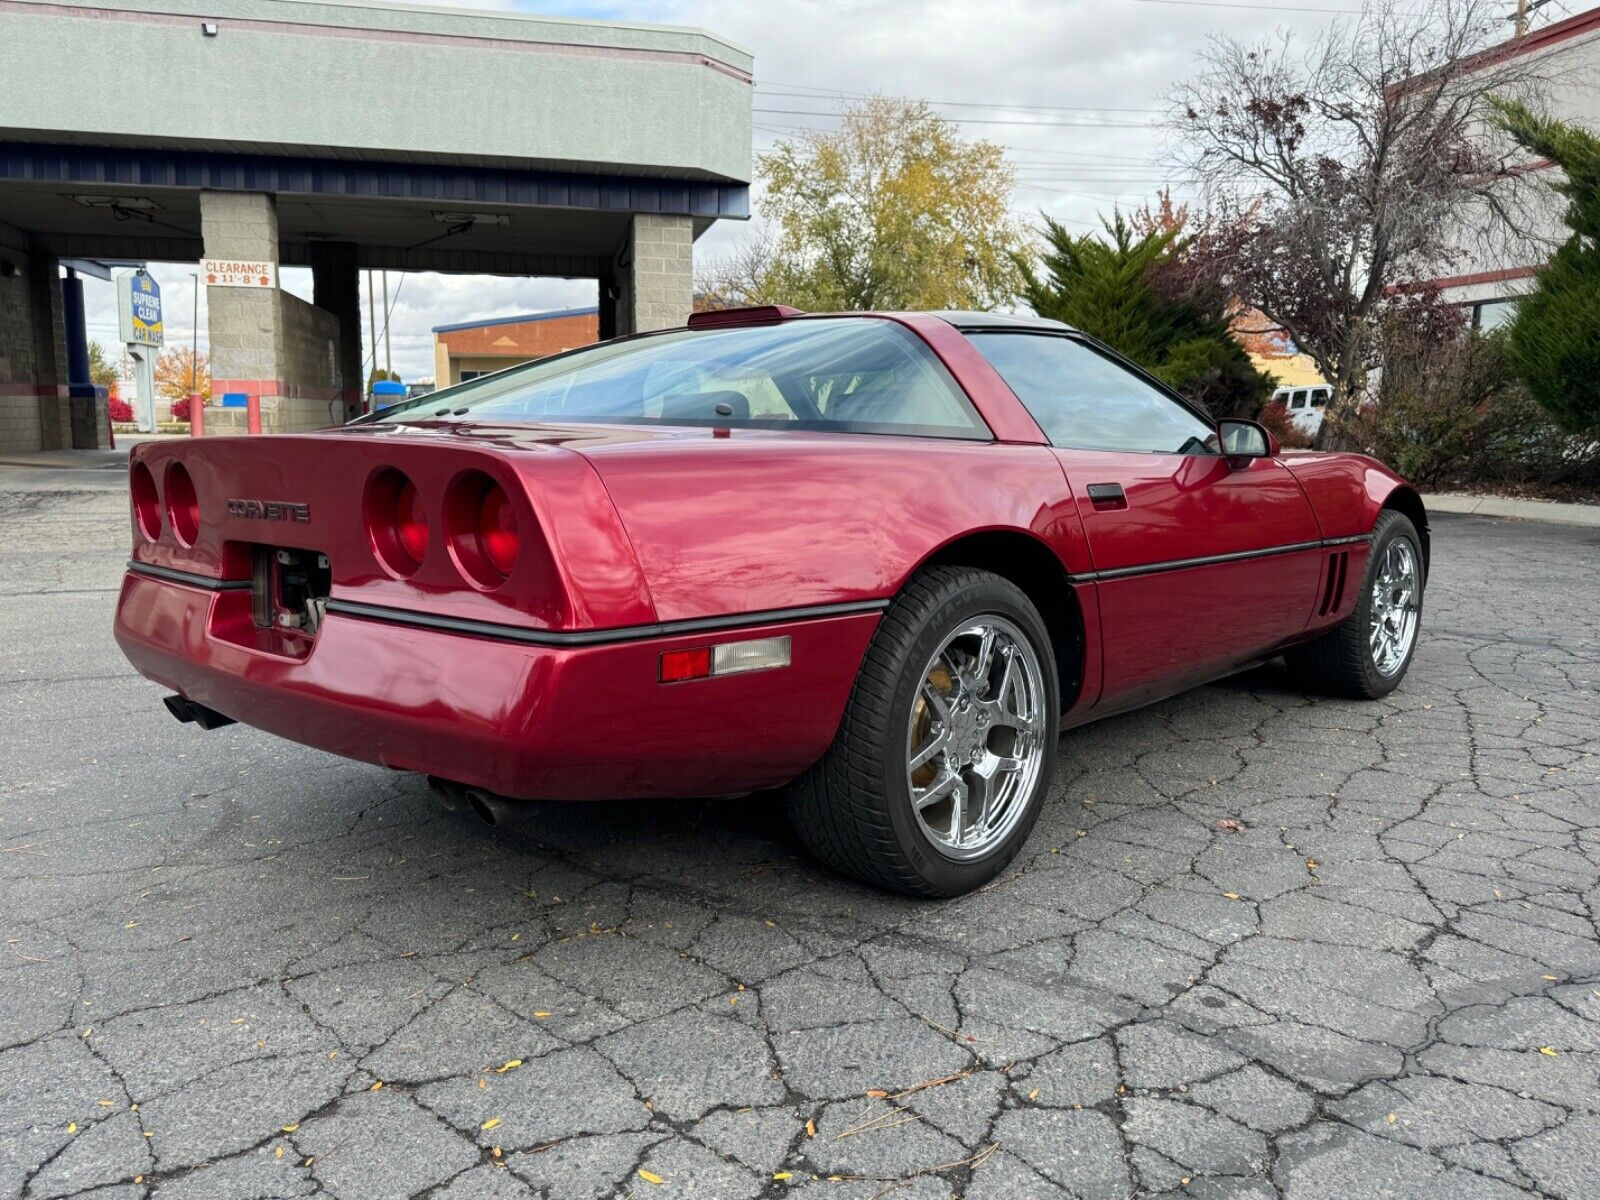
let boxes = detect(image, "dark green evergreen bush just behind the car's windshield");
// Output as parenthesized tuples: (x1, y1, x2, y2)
(1018, 213, 1272, 418)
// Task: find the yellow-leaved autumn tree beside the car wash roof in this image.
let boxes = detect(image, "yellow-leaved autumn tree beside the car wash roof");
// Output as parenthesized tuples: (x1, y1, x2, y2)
(699, 96, 1021, 312)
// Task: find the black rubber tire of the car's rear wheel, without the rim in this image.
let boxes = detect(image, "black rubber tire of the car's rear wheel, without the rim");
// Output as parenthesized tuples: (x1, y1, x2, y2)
(787, 566, 1061, 896)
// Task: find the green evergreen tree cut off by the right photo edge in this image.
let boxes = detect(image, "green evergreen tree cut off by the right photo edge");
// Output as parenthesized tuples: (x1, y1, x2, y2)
(1496, 99, 1600, 437)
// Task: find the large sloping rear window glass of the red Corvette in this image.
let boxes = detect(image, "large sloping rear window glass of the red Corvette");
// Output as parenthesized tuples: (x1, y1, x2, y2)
(379, 317, 989, 438)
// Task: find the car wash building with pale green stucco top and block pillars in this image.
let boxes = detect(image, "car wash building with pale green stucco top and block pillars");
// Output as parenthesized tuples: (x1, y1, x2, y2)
(0, 0, 752, 451)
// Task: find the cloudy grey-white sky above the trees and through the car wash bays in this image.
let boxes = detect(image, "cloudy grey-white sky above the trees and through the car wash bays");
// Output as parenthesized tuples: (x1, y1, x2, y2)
(85, 0, 1452, 381)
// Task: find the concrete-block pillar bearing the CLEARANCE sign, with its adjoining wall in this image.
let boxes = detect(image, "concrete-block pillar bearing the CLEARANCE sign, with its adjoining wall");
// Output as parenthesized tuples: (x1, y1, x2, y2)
(200, 192, 344, 437)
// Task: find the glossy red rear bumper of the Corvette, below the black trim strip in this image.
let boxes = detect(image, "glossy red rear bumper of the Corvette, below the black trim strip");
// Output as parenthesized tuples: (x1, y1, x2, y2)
(115, 571, 878, 800)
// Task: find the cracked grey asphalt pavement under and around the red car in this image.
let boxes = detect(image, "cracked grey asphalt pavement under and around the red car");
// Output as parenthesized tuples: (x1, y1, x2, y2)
(0, 469, 1600, 1200)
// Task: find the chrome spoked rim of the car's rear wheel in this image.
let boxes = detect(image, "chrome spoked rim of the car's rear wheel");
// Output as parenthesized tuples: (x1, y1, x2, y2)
(906, 616, 1056, 861)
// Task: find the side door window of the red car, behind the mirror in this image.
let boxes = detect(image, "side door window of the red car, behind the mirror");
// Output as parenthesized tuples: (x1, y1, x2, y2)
(968, 331, 1216, 454)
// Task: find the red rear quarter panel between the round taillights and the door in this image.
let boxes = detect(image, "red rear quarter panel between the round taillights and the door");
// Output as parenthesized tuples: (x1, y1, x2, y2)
(586, 430, 1088, 621)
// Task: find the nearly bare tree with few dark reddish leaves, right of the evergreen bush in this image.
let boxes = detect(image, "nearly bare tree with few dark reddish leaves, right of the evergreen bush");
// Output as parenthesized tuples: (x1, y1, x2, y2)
(1171, 0, 1552, 445)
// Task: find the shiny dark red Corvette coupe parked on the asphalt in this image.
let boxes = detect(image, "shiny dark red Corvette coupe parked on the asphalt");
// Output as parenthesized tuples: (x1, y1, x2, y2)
(117, 307, 1429, 896)
